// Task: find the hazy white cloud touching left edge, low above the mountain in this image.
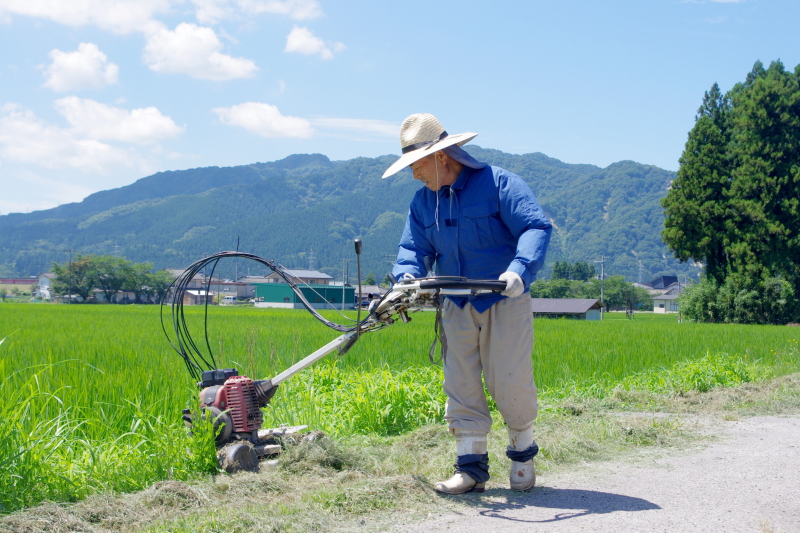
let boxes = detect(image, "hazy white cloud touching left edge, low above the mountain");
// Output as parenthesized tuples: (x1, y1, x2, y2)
(0, 104, 135, 174)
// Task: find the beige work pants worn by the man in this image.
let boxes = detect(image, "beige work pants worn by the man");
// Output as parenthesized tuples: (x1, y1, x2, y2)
(442, 293, 537, 433)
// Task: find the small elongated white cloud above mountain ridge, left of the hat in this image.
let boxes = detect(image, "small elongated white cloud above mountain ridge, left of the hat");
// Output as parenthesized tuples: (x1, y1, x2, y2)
(211, 102, 314, 138)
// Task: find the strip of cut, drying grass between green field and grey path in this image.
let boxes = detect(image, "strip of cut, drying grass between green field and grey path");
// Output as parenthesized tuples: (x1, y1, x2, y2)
(0, 368, 800, 533)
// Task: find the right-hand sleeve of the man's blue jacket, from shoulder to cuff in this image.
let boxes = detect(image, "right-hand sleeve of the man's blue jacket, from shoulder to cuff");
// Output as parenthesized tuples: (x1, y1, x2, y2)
(498, 172, 553, 288)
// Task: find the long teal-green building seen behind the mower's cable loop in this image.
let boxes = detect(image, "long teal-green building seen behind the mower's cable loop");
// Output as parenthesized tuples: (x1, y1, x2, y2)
(255, 282, 355, 309)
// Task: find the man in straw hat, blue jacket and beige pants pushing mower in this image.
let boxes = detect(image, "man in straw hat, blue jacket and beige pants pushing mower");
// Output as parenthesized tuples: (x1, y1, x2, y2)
(383, 113, 552, 494)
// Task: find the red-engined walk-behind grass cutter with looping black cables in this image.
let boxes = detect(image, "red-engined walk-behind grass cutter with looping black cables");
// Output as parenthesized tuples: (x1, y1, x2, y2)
(161, 239, 505, 472)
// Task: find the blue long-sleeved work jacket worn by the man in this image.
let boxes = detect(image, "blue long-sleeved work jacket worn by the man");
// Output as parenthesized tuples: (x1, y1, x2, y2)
(392, 166, 552, 313)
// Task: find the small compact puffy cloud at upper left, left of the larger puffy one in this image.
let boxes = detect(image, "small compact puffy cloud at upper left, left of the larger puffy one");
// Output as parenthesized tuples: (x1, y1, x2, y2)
(44, 43, 119, 92)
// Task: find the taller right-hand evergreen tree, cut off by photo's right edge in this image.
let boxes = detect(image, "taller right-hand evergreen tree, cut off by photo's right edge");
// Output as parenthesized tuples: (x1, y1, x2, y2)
(729, 61, 800, 293)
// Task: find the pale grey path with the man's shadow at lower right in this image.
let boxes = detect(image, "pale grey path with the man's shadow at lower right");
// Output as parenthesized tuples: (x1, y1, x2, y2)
(395, 417, 800, 533)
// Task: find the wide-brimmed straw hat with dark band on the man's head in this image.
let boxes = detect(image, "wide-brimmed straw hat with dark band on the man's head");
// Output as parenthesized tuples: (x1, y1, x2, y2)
(383, 113, 478, 178)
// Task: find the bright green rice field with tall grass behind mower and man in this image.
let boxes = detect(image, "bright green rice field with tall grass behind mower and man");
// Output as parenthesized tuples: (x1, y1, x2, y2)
(0, 304, 797, 512)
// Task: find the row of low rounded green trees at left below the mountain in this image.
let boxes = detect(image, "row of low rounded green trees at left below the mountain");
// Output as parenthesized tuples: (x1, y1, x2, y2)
(51, 254, 174, 303)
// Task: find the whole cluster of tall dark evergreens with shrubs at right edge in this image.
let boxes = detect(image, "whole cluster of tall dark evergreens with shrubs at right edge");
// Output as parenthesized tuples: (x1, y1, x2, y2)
(662, 61, 800, 324)
